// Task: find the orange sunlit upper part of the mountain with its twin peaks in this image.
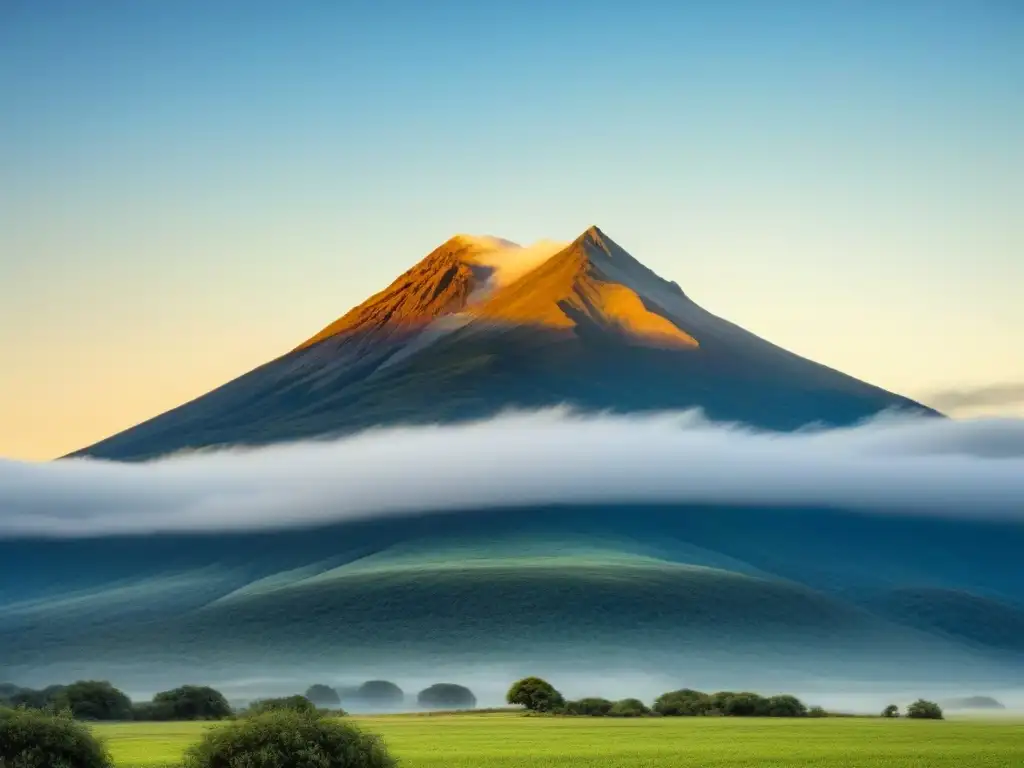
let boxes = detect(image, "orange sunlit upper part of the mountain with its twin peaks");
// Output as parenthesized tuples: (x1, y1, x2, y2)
(298, 227, 698, 349)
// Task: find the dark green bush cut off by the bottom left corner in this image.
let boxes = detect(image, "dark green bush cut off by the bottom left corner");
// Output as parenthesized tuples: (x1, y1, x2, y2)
(0, 710, 114, 768)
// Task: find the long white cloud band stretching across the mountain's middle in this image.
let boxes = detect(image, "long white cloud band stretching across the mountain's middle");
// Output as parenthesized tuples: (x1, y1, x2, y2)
(0, 409, 1024, 539)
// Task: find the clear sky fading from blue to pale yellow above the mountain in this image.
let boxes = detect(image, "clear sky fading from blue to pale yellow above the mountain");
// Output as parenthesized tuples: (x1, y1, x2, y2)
(0, 0, 1024, 459)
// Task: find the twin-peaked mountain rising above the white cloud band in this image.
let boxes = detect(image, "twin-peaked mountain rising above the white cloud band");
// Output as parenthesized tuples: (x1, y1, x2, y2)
(73, 227, 934, 460)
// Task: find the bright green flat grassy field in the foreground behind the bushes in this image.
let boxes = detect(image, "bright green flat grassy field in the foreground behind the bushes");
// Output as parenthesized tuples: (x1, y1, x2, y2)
(96, 714, 1024, 768)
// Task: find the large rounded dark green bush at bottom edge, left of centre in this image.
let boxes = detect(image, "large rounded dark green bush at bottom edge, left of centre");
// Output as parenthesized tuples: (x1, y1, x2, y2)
(183, 710, 395, 768)
